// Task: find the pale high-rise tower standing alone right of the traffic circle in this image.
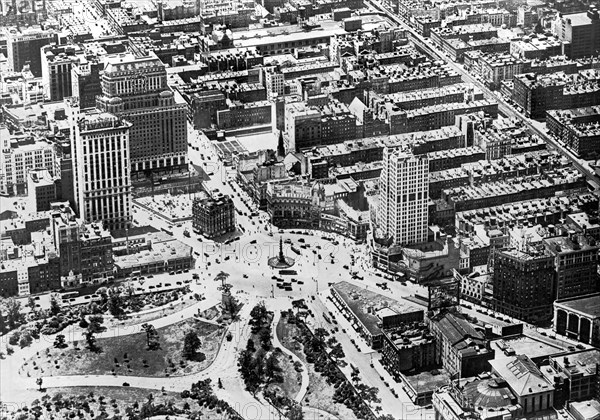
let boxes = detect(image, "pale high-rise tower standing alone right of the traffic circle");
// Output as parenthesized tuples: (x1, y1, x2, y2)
(377, 147, 429, 245)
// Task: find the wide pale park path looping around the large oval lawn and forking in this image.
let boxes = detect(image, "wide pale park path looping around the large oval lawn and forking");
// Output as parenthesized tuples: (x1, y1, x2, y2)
(0, 300, 279, 420)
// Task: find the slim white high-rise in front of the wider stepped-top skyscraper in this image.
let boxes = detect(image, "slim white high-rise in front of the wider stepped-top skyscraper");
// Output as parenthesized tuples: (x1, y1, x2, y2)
(71, 108, 131, 230)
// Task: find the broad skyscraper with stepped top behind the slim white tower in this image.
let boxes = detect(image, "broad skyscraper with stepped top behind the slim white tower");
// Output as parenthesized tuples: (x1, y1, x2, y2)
(96, 53, 188, 178)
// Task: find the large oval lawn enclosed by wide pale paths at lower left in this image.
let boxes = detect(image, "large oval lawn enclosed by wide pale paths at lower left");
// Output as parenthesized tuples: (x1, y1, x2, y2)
(23, 319, 225, 377)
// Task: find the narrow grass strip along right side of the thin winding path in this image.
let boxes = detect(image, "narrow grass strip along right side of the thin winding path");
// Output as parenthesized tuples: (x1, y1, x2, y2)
(276, 318, 356, 420)
